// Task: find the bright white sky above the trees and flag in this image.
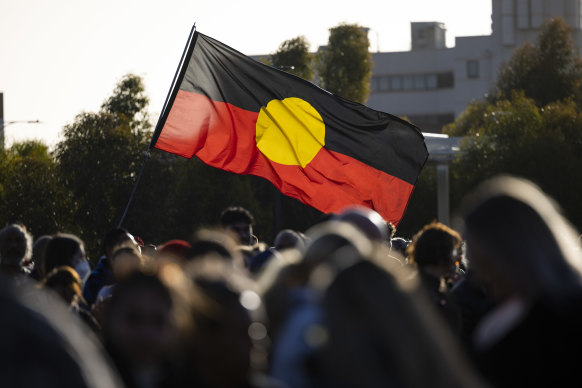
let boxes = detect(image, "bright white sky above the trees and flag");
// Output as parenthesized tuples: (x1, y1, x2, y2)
(0, 0, 491, 147)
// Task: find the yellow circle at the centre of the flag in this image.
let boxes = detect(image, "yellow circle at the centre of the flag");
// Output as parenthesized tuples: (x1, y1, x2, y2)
(256, 97, 325, 167)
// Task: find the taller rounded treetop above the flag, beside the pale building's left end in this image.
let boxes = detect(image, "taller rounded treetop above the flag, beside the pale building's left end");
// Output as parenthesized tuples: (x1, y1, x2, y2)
(317, 24, 372, 103)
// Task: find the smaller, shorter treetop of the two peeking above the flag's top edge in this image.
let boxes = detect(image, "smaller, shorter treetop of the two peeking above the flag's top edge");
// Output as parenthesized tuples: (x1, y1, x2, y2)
(271, 36, 313, 81)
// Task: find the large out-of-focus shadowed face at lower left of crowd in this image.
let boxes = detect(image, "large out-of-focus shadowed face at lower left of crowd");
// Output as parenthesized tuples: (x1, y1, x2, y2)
(108, 287, 175, 366)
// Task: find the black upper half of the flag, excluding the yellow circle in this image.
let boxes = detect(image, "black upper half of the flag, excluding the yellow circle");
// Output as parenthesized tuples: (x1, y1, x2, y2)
(169, 32, 428, 185)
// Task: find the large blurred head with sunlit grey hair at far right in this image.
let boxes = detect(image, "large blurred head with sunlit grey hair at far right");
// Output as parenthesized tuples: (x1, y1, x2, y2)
(461, 176, 582, 301)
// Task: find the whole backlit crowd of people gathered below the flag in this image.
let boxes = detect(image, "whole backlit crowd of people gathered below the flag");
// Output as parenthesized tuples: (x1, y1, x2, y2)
(0, 176, 582, 388)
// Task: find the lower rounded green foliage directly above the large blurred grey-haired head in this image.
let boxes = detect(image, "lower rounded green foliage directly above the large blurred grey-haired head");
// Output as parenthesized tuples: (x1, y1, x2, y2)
(452, 92, 582, 226)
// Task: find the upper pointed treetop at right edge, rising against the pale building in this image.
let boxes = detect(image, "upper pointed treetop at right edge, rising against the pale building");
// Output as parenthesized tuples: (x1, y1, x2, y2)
(493, 18, 582, 107)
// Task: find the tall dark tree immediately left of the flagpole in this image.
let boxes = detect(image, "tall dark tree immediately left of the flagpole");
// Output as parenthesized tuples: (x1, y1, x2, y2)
(55, 74, 151, 254)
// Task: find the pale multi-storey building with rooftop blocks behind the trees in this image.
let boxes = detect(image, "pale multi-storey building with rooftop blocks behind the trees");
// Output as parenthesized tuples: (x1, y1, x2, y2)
(367, 0, 582, 133)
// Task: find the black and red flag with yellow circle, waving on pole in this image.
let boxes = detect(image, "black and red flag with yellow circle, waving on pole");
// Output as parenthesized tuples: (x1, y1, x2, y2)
(152, 31, 428, 225)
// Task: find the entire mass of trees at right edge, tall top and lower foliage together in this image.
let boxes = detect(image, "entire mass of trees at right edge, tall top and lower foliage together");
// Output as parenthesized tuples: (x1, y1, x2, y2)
(444, 19, 582, 228)
